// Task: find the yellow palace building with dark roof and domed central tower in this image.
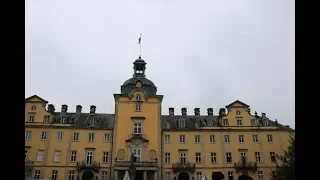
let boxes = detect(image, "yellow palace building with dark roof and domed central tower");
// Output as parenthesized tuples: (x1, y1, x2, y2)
(25, 57, 294, 180)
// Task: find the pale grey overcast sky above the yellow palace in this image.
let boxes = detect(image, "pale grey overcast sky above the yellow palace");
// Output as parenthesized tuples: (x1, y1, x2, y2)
(25, 0, 295, 127)
